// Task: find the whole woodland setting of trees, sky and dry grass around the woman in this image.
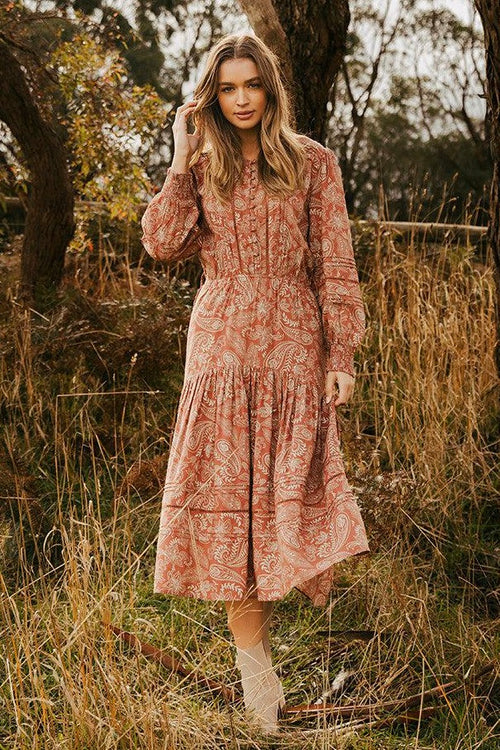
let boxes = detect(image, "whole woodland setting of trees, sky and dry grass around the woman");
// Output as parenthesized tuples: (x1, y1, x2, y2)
(0, 0, 500, 750)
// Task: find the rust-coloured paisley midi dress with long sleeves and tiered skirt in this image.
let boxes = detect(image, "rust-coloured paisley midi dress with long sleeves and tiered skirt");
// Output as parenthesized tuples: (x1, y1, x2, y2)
(141, 136, 369, 606)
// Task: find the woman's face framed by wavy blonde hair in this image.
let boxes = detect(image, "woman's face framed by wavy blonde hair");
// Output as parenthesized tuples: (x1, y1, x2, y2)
(217, 57, 267, 132)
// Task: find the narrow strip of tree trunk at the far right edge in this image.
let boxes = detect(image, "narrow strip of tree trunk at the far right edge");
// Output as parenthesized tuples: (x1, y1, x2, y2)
(476, 0, 500, 375)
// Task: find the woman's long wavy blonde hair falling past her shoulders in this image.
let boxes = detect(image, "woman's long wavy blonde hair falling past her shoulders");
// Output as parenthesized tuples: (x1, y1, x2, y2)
(189, 34, 306, 202)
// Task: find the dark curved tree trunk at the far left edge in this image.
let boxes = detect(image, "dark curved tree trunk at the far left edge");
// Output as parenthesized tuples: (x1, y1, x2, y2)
(0, 38, 75, 304)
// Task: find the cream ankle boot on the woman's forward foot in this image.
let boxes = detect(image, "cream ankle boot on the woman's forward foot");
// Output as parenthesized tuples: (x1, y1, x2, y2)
(236, 640, 284, 733)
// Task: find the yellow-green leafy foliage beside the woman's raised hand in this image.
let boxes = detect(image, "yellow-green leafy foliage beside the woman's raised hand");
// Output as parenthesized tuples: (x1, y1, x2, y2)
(52, 32, 165, 220)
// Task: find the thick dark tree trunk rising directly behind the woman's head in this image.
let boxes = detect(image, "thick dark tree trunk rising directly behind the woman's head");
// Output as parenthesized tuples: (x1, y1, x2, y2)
(240, 0, 350, 143)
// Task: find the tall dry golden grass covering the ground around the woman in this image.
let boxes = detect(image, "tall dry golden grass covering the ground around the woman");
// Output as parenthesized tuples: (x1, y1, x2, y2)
(0, 225, 500, 750)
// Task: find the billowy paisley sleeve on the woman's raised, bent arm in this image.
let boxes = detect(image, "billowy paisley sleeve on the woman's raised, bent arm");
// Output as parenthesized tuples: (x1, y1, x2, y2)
(141, 167, 204, 261)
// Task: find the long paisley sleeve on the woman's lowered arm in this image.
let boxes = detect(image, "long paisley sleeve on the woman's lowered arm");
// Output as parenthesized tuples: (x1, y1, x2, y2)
(309, 148, 366, 375)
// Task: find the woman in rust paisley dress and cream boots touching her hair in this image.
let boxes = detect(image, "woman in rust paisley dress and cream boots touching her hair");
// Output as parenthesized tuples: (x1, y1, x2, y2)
(142, 35, 369, 732)
